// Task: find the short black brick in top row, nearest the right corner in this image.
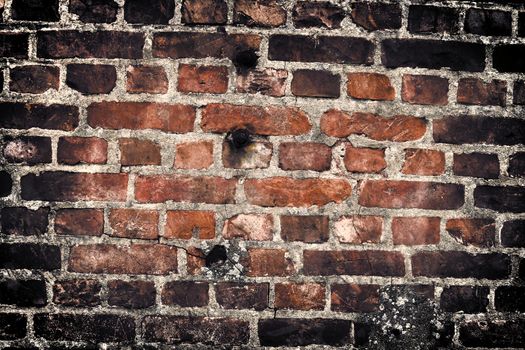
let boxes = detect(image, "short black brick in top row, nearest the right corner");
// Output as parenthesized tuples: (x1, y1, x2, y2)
(465, 8, 512, 36)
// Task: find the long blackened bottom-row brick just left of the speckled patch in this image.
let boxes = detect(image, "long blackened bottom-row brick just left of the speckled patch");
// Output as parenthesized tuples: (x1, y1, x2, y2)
(257, 318, 351, 346)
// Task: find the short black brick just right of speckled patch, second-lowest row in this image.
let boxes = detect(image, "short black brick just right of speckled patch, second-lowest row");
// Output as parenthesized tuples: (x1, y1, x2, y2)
(440, 286, 489, 314)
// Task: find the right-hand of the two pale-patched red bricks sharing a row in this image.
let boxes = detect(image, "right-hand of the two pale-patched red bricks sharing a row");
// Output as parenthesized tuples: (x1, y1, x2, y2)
(334, 215, 383, 244)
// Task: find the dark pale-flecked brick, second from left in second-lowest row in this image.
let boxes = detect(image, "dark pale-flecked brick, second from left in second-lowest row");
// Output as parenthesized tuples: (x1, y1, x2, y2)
(53, 279, 102, 307)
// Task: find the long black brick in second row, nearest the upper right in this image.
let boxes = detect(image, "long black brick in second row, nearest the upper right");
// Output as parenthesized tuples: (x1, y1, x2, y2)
(381, 39, 485, 72)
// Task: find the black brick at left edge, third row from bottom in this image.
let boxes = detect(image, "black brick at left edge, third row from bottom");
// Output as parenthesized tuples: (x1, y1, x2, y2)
(0, 243, 61, 270)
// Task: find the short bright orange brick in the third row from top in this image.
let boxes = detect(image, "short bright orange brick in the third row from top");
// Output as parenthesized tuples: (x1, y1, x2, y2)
(346, 73, 396, 101)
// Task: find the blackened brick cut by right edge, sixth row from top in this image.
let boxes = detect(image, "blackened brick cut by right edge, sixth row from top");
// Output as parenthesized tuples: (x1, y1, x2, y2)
(474, 186, 525, 213)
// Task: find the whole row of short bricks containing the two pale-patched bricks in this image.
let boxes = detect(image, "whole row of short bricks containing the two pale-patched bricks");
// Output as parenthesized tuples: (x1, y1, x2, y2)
(4, 207, 525, 248)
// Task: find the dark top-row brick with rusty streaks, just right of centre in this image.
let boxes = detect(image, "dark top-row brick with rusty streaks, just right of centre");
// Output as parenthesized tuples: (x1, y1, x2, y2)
(292, 1, 346, 29)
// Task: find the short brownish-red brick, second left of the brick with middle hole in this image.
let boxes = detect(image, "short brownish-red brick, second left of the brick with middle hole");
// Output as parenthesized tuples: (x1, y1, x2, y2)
(119, 138, 161, 166)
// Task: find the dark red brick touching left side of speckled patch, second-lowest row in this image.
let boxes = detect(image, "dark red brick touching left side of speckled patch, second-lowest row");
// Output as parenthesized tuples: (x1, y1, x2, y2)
(330, 284, 379, 312)
